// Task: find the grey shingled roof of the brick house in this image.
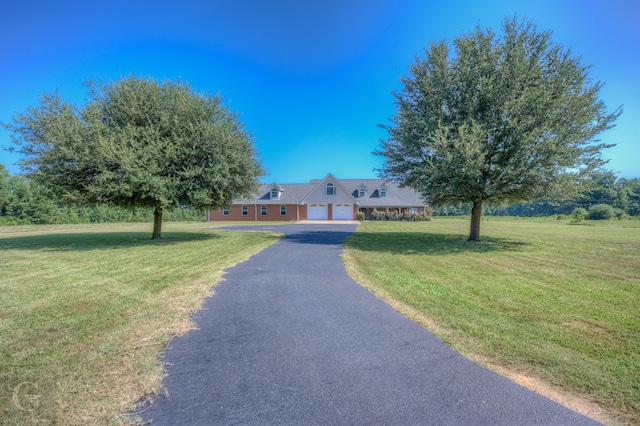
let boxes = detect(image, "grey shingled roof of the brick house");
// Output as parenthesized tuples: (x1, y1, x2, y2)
(234, 174, 426, 208)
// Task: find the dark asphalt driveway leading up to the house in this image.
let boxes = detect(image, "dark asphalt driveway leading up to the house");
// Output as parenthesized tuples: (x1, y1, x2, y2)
(142, 224, 595, 425)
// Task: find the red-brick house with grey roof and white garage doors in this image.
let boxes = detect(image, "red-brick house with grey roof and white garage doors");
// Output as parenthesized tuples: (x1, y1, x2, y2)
(207, 173, 426, 221)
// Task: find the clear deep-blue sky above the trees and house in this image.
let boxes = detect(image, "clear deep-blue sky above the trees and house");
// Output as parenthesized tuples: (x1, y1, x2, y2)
(0, 0, 640, 183)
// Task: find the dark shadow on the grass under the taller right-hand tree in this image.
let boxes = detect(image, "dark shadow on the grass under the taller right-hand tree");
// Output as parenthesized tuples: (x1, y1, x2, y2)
(344, 232, 531, 255)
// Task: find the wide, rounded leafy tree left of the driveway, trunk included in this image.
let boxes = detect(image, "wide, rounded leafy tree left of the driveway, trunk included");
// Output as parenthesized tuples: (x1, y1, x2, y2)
(5, 77, 263, 239)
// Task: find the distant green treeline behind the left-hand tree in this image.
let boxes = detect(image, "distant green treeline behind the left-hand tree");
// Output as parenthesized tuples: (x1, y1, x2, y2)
(0, 164, 206, 225)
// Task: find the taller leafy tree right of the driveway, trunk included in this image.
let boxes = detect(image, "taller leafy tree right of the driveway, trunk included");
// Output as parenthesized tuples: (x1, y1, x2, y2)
(376, 18, 621, 241)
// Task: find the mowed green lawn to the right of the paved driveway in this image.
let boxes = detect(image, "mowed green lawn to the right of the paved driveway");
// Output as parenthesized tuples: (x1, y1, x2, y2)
(344, 218, 640, 424)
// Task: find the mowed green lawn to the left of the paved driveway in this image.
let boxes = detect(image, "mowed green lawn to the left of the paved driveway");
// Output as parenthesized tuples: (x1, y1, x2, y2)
(0, 222, 279, 425)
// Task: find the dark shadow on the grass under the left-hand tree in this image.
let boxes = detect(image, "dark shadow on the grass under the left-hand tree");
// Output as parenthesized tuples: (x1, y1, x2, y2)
(0, 232, 221, 251)
